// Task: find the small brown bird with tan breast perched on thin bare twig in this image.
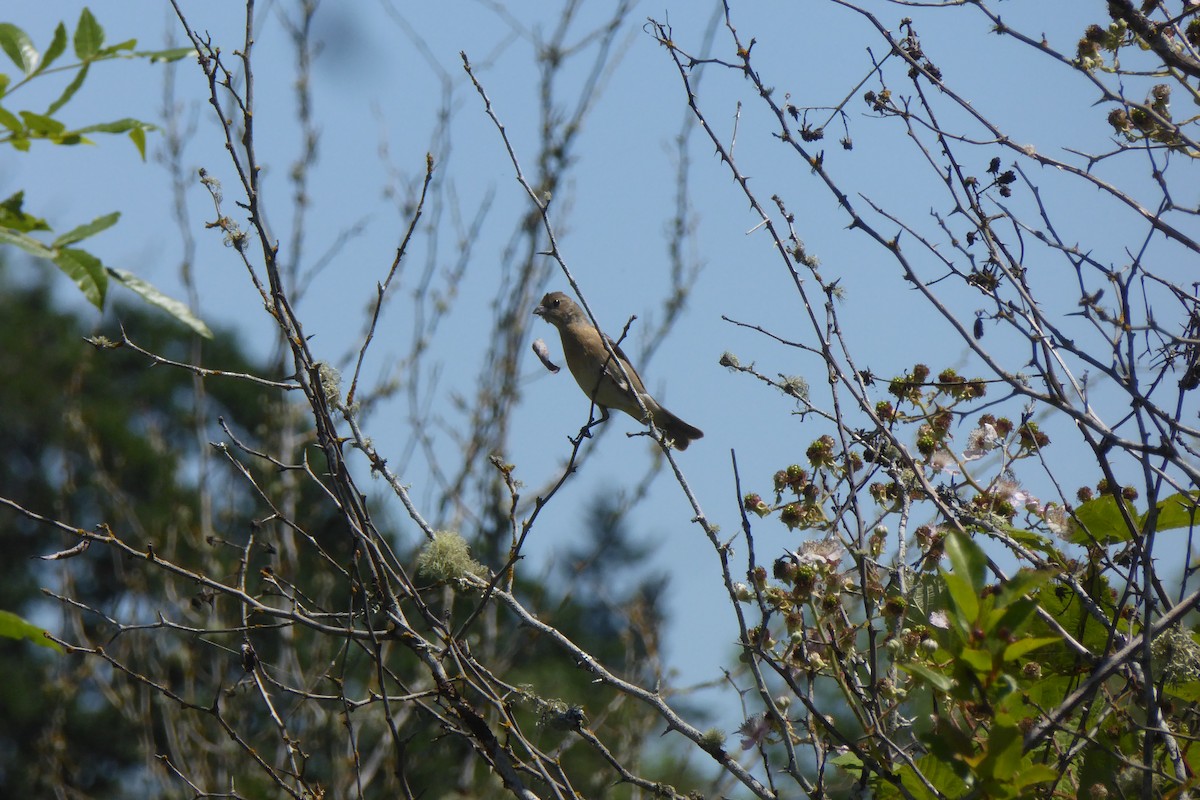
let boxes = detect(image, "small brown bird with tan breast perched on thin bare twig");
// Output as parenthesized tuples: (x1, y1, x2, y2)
(533, 291, 704, 450)
